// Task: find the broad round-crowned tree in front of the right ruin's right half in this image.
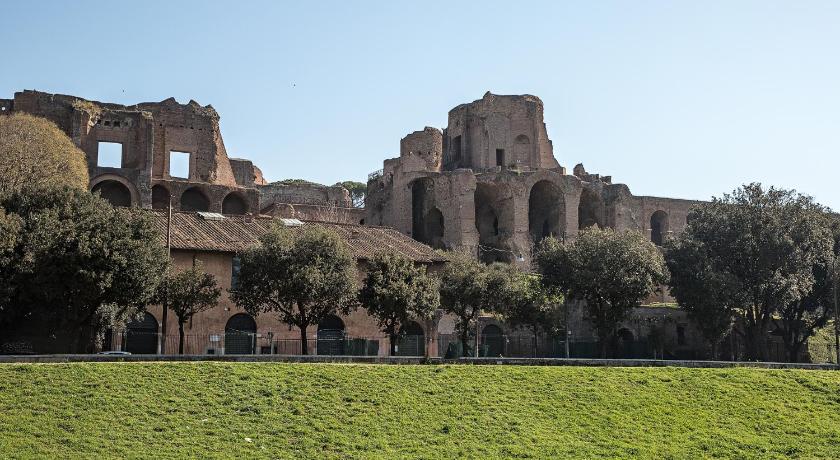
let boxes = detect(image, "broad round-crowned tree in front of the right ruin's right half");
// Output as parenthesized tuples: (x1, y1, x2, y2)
(536, 226, 668, 357)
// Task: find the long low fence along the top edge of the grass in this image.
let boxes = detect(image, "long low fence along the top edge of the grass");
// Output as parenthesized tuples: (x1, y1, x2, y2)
(0, 331, 837, 363)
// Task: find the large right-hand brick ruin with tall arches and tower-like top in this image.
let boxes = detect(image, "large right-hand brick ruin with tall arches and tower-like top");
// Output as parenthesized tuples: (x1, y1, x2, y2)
(366, 92, 697, 267)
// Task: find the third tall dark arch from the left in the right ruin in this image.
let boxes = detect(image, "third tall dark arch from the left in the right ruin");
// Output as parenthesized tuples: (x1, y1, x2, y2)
(528, 180, 566, 243)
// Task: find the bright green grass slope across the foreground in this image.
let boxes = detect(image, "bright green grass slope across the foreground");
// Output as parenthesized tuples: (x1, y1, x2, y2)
(0, 363, 840, 458)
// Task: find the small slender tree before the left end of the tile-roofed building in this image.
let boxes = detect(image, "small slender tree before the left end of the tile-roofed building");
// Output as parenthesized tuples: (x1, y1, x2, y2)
(155, 263, 222, 354)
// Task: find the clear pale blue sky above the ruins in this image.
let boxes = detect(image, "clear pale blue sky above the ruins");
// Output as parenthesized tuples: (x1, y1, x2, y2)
(0, 0, 840, 209)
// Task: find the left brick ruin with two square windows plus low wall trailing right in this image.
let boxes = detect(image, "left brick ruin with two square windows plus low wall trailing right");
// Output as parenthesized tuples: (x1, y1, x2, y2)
(0, 90, 364, 223)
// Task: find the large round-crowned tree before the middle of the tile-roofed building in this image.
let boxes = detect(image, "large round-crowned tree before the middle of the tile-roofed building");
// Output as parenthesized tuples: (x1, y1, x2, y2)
(231, 225, 357, 354)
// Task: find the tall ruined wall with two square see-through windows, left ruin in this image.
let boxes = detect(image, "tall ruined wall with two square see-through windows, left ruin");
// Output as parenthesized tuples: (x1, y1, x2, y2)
(5, 90, 262, 214)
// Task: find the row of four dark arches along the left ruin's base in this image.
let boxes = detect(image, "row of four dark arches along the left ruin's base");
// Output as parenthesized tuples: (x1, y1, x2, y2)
(91, 179, 249, 215)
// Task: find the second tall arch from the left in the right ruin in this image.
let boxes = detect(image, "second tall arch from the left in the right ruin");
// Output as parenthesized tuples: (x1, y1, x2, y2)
(474, 183, 513, 263)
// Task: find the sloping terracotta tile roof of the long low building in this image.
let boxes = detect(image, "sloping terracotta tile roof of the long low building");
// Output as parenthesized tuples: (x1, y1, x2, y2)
(150, 211, 446, 263)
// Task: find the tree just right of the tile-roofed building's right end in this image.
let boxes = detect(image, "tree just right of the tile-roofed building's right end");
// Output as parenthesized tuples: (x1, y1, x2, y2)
(440, 252, 517, 356)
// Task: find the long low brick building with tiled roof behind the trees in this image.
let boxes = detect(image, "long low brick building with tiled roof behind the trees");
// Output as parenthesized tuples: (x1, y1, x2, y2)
(113, 211, 446, 355)
